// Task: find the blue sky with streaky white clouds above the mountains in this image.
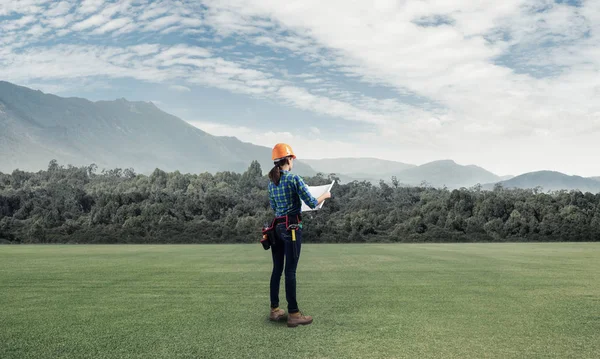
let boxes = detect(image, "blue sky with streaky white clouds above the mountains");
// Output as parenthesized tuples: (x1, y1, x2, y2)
(0, 0, 600, 176)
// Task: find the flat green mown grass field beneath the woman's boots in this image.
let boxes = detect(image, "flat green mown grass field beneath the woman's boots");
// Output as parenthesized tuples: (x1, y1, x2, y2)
(0, 243, 600, 359)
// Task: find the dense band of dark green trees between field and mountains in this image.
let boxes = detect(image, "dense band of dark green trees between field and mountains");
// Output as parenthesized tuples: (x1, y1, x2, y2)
(0, 161, 600, 243)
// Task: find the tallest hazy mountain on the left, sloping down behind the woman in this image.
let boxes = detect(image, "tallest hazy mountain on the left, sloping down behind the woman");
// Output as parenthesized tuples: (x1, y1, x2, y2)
(0, 81, 316, 175)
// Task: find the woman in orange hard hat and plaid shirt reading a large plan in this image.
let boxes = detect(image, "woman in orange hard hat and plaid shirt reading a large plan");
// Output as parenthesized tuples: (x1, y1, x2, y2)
(269, 143, 331, 327)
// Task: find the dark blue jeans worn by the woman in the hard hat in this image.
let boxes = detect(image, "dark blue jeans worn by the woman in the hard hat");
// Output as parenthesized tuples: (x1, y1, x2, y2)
(271, 223, 302, 313)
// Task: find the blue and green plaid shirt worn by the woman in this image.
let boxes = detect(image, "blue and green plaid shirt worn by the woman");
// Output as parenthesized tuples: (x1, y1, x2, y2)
(269, 170, 318, 217)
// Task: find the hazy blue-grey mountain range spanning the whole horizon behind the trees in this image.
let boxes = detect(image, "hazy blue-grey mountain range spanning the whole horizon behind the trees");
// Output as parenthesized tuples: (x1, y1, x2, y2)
(0, 81, 600, 192)
